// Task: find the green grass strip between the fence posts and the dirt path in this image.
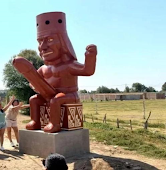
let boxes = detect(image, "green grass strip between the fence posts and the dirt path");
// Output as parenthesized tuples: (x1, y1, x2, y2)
(84, 122, 166, 159)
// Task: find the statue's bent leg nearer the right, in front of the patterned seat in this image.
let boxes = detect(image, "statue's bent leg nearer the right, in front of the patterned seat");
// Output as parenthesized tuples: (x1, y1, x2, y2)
(44, 93, 79, 133)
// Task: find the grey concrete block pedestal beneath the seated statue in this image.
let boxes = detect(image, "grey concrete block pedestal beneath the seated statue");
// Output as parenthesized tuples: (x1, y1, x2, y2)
(19, 129, 90, 158)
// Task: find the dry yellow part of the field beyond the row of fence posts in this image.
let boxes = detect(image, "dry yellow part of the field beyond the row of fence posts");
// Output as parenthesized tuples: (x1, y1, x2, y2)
(83, 100, 166, 124)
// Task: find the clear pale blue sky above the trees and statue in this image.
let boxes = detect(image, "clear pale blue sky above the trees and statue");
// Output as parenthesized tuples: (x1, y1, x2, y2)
(0, 0, 166, 90)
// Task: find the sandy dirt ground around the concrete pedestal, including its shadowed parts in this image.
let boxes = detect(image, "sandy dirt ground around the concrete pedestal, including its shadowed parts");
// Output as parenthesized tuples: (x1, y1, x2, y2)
(0, 115, 166, 170)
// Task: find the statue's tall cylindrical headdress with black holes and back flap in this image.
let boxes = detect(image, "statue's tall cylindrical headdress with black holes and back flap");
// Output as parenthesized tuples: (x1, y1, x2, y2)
(36, 12, 77, 59)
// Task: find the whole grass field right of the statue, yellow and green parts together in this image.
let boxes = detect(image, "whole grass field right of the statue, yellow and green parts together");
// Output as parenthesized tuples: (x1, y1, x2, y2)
(83, 100, 166, 159)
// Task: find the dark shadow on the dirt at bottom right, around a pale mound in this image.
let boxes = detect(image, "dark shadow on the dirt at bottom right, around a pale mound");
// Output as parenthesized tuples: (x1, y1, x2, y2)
(67, 153, 158, 170)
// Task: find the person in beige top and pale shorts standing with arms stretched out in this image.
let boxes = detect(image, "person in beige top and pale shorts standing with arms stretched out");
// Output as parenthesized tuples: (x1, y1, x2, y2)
(6, 99, 29, 147)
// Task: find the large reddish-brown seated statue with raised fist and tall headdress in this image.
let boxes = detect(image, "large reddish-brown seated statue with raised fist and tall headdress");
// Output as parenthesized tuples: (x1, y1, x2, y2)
(13, 12, 97, 133)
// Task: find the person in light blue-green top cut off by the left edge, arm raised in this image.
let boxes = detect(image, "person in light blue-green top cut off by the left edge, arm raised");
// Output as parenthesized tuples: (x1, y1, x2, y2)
(0, 96, 15, 151)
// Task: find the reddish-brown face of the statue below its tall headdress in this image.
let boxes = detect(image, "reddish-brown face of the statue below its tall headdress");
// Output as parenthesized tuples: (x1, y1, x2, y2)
(37, 34, 61, 62)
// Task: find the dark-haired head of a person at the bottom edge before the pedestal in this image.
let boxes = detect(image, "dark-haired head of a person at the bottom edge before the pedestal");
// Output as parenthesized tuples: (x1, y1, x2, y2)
(43, 153, 68, 170)
